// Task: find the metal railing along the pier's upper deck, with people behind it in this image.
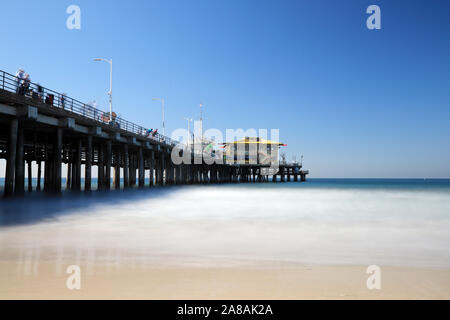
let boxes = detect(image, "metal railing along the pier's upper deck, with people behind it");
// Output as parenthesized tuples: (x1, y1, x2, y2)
(0, 70, 181, 146)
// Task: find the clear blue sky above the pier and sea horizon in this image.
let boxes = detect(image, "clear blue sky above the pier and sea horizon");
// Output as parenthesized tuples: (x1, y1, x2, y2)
(0, 0, 450, 178)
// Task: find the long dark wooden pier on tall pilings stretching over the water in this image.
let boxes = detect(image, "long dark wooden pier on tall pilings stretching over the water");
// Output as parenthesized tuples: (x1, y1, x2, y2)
(0, 71, 308, 197)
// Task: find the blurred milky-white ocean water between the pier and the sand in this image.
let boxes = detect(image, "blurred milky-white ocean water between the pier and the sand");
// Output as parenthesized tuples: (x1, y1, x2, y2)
(0, 179, 450, 268)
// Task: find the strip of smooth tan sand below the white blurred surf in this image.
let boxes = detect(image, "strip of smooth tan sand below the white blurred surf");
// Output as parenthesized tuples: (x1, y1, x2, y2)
(0, 262, 450, 299)
